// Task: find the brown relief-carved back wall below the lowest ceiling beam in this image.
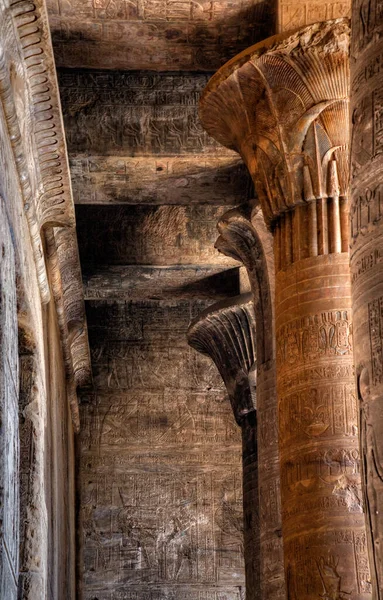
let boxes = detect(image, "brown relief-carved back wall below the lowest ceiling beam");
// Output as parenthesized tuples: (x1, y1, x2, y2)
(79, 300, 244, 600)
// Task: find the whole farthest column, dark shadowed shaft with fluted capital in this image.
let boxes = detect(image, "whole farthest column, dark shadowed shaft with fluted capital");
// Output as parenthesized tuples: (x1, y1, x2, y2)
(188, 294, 260, 600)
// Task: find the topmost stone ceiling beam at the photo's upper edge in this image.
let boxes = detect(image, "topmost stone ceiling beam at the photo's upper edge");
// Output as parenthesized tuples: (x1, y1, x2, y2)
(47, 0, 275, 71)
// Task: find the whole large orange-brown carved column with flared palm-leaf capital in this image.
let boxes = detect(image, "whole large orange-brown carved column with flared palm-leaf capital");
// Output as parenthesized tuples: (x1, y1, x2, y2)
(201, 19, 371, 600)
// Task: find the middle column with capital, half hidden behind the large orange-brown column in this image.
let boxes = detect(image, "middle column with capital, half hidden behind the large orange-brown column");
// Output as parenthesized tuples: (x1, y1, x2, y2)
(216, 205, 286, 600)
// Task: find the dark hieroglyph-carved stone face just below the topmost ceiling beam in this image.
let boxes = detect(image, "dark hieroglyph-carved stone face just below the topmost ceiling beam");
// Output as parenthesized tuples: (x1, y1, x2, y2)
(60, 70, 224, 156)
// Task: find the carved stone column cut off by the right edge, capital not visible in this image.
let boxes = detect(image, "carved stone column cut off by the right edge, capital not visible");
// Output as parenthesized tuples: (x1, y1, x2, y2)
(350, 0, 383, 599)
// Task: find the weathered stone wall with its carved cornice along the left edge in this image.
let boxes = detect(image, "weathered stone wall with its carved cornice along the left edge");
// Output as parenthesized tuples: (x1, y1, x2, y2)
(0, 0, 89, 600)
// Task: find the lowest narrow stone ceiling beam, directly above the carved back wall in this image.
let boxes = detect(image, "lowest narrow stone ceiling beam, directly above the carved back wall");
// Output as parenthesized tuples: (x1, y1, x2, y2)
(84, 265, 240, 300)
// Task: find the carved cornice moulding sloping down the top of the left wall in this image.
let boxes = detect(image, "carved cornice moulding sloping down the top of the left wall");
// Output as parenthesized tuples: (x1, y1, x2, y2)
(0, 0, 90, 427)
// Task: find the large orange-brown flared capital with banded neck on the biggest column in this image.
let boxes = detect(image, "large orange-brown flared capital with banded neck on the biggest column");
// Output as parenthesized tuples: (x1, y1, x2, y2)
(200, 19, 349, 270)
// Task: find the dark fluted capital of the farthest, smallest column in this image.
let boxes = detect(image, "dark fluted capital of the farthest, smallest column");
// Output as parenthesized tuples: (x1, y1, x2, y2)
(188, 294, 256, 424)
